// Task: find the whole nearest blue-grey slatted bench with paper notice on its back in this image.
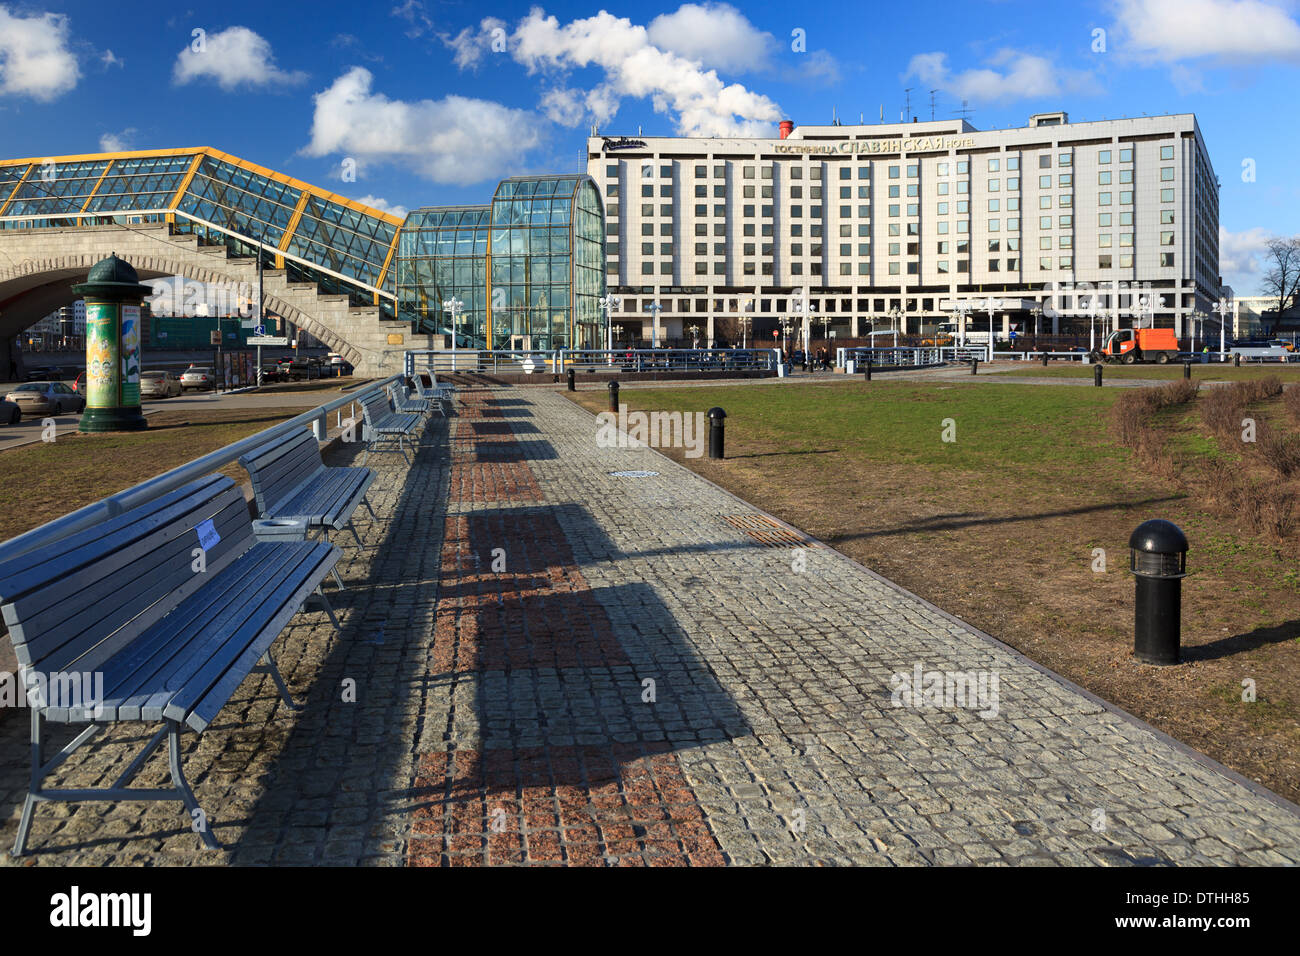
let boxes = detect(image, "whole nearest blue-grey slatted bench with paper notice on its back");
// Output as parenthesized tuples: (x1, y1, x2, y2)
(0, 475, 339, 856)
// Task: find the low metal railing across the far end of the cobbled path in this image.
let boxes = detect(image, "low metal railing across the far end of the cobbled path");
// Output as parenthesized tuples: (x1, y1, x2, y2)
(404, 349, 780, 376)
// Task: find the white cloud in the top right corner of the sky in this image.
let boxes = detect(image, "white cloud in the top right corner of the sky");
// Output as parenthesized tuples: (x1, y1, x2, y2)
(1115, 0, 1300, 62)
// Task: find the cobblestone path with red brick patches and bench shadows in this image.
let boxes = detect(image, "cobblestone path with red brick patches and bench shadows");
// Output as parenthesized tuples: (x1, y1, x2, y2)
(0, 389, 1300, 866)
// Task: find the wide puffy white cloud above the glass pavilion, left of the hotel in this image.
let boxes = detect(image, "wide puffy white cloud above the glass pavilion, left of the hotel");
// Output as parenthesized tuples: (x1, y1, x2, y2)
(303, 66, 540, 185)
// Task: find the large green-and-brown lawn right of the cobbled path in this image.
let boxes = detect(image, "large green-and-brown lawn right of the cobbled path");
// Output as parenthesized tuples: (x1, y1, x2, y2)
(569, 369, 1300, 800)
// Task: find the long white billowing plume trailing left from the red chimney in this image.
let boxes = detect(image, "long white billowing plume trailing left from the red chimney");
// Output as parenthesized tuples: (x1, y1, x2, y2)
(445, 7, 781, 137)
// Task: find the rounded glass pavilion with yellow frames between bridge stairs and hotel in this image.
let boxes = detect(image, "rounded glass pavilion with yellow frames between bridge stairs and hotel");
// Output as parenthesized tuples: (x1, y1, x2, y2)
(397, 174, 605, 349)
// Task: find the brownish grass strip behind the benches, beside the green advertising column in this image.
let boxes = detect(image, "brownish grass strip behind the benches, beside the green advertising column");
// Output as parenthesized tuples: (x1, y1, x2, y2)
(0, 408, 302, 541)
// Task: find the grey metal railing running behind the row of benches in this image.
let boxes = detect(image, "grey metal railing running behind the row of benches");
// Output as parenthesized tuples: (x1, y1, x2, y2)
(0, 375, 402, 562)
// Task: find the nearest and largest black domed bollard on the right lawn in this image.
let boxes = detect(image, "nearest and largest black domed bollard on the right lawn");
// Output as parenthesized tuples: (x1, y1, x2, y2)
(1128, 518, 1187, 665)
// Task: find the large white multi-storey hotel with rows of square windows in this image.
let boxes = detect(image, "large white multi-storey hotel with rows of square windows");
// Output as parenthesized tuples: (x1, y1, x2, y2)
(588, 112, 1221, 345)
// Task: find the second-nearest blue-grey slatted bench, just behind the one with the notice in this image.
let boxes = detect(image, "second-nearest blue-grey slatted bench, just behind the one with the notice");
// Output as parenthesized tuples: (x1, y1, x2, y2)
(239, 429, 378, 561)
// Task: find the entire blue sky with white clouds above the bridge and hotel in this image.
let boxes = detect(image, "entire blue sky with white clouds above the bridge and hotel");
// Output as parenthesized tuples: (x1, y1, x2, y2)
(0, 0, 1300, 294)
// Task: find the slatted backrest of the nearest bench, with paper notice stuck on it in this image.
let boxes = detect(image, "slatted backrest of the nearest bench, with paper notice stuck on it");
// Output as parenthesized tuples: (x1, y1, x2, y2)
(0, 475, 254, 672)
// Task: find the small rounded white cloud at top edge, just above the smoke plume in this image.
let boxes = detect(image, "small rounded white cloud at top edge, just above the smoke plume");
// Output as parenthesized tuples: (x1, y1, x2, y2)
(646, 3, 776, 73)
